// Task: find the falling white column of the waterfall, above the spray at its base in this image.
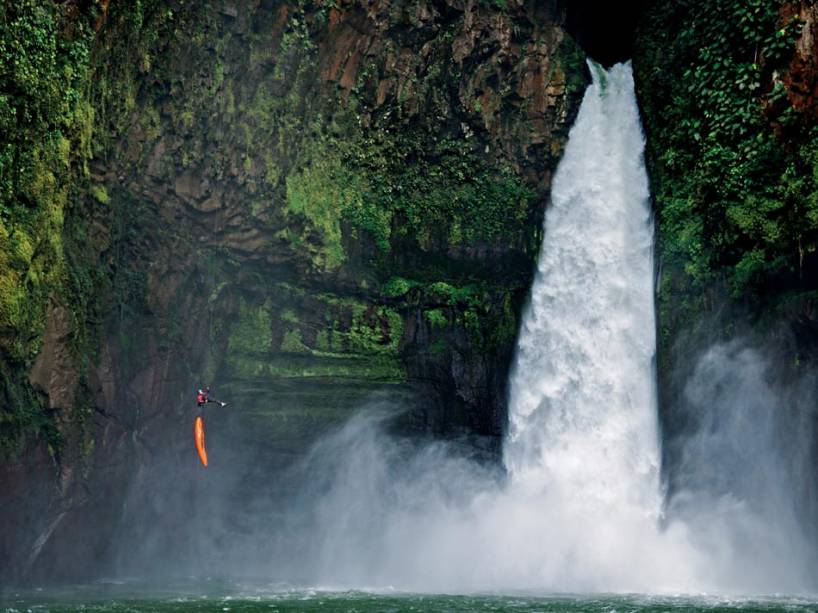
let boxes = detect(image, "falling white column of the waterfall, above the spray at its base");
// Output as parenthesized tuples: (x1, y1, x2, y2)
(505, 64, 661, 518)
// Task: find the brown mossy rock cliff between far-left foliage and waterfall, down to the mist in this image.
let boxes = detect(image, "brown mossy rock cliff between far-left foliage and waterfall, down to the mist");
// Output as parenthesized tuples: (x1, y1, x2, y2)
(0, 0, 586, 581)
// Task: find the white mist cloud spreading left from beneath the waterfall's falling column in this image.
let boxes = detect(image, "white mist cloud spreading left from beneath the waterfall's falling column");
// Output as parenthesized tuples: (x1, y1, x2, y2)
(274, 411, 695, 592)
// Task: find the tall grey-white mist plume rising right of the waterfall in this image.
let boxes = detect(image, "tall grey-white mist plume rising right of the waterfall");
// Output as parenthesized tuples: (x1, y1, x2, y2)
(668, 341, 816, 592)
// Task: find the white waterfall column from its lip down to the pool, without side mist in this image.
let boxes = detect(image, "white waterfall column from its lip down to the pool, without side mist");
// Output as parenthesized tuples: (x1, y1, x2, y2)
(468, 59, 699, 590)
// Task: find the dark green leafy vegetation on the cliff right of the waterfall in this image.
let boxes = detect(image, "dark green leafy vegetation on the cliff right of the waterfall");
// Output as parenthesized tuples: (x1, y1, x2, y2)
(636, 0, 818, 340)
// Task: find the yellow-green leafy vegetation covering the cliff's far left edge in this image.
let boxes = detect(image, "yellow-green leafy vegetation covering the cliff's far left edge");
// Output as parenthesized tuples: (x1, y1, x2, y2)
(0, 0, 171, 454)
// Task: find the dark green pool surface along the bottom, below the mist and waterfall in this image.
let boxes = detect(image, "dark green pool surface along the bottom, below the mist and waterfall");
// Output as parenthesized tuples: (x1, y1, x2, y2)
(0, 582, 818, 613)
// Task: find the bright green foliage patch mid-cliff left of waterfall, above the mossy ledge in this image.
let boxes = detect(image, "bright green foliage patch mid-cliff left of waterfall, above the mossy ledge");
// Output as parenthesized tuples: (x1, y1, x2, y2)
(286, 109, 536, 271)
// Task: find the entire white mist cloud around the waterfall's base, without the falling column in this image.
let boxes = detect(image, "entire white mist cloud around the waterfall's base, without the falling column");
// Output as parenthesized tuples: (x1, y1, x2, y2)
(266, 342, 815, 595)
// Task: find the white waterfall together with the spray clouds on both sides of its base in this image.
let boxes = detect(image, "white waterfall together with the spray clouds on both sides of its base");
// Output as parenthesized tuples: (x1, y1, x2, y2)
(256, 59, 812, 593)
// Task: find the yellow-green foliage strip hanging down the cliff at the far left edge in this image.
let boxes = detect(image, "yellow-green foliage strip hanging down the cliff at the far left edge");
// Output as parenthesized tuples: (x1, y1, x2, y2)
(0, 0, 99, 454)
